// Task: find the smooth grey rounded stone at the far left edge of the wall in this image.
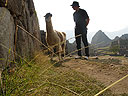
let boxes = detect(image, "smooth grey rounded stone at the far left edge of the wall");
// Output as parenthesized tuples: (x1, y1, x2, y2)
(0, 7, 15, 68)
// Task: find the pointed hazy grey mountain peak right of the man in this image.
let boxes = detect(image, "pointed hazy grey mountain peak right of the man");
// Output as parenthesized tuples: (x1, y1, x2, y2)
(91, 30, 112, 48)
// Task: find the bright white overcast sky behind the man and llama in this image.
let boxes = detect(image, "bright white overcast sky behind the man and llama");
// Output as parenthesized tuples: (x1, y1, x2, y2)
(33, 0, 128, 42)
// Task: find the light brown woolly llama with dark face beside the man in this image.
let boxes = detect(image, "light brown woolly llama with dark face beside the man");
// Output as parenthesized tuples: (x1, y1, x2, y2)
(44, 13, 66, 60)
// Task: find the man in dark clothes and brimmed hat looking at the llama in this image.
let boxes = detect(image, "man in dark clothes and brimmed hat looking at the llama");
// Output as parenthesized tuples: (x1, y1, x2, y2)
(71, 1, 89, 59)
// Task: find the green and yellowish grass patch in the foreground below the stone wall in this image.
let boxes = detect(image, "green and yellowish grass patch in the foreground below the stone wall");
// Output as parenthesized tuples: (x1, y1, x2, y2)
(0, 55, 114, 96)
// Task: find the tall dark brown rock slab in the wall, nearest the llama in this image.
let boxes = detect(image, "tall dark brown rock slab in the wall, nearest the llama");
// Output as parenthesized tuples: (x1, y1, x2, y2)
(16, 0, 41, 58)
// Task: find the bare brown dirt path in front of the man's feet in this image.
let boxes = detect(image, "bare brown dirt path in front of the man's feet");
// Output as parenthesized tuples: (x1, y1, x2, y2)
(63, 56, 128, 94)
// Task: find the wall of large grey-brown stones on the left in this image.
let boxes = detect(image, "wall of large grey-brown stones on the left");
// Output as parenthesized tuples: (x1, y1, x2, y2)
(0, 0, 40, 67)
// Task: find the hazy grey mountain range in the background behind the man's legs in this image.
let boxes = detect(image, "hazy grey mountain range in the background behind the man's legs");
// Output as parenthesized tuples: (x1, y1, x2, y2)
(66, 30, 128, 56)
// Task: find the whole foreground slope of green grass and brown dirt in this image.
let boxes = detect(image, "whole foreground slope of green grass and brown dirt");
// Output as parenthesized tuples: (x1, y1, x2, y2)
(1, 53, 128, 96)
